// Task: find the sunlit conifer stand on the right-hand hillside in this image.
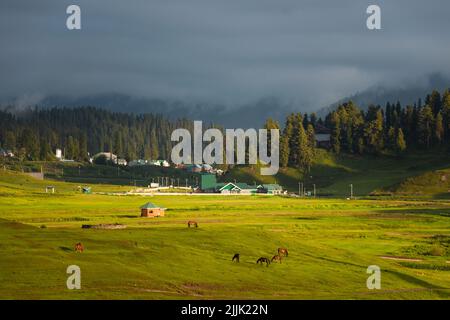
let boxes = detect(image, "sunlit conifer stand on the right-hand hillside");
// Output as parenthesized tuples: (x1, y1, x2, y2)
(274, 90, 450, 171)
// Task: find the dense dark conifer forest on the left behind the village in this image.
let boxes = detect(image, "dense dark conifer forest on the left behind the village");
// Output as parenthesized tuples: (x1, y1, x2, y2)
(0, 107, 192, 160)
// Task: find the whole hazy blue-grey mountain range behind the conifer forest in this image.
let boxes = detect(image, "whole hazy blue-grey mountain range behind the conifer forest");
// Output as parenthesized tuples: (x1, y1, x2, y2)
(1, 74, 450, 128)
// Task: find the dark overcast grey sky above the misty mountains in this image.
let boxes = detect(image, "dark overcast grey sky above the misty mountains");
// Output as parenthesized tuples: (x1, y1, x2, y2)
(0, 0, 450, 109)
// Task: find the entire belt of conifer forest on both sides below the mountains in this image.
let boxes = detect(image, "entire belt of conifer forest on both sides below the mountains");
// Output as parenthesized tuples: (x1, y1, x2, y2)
(0, 90, 450, 171)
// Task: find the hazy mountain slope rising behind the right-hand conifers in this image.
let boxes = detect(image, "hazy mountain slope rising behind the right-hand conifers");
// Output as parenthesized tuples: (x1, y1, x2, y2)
(317, 74, 450, 117)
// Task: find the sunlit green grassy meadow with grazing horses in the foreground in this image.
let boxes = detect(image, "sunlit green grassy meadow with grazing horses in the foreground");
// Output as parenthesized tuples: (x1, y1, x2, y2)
(0, 171, 450, 299)
